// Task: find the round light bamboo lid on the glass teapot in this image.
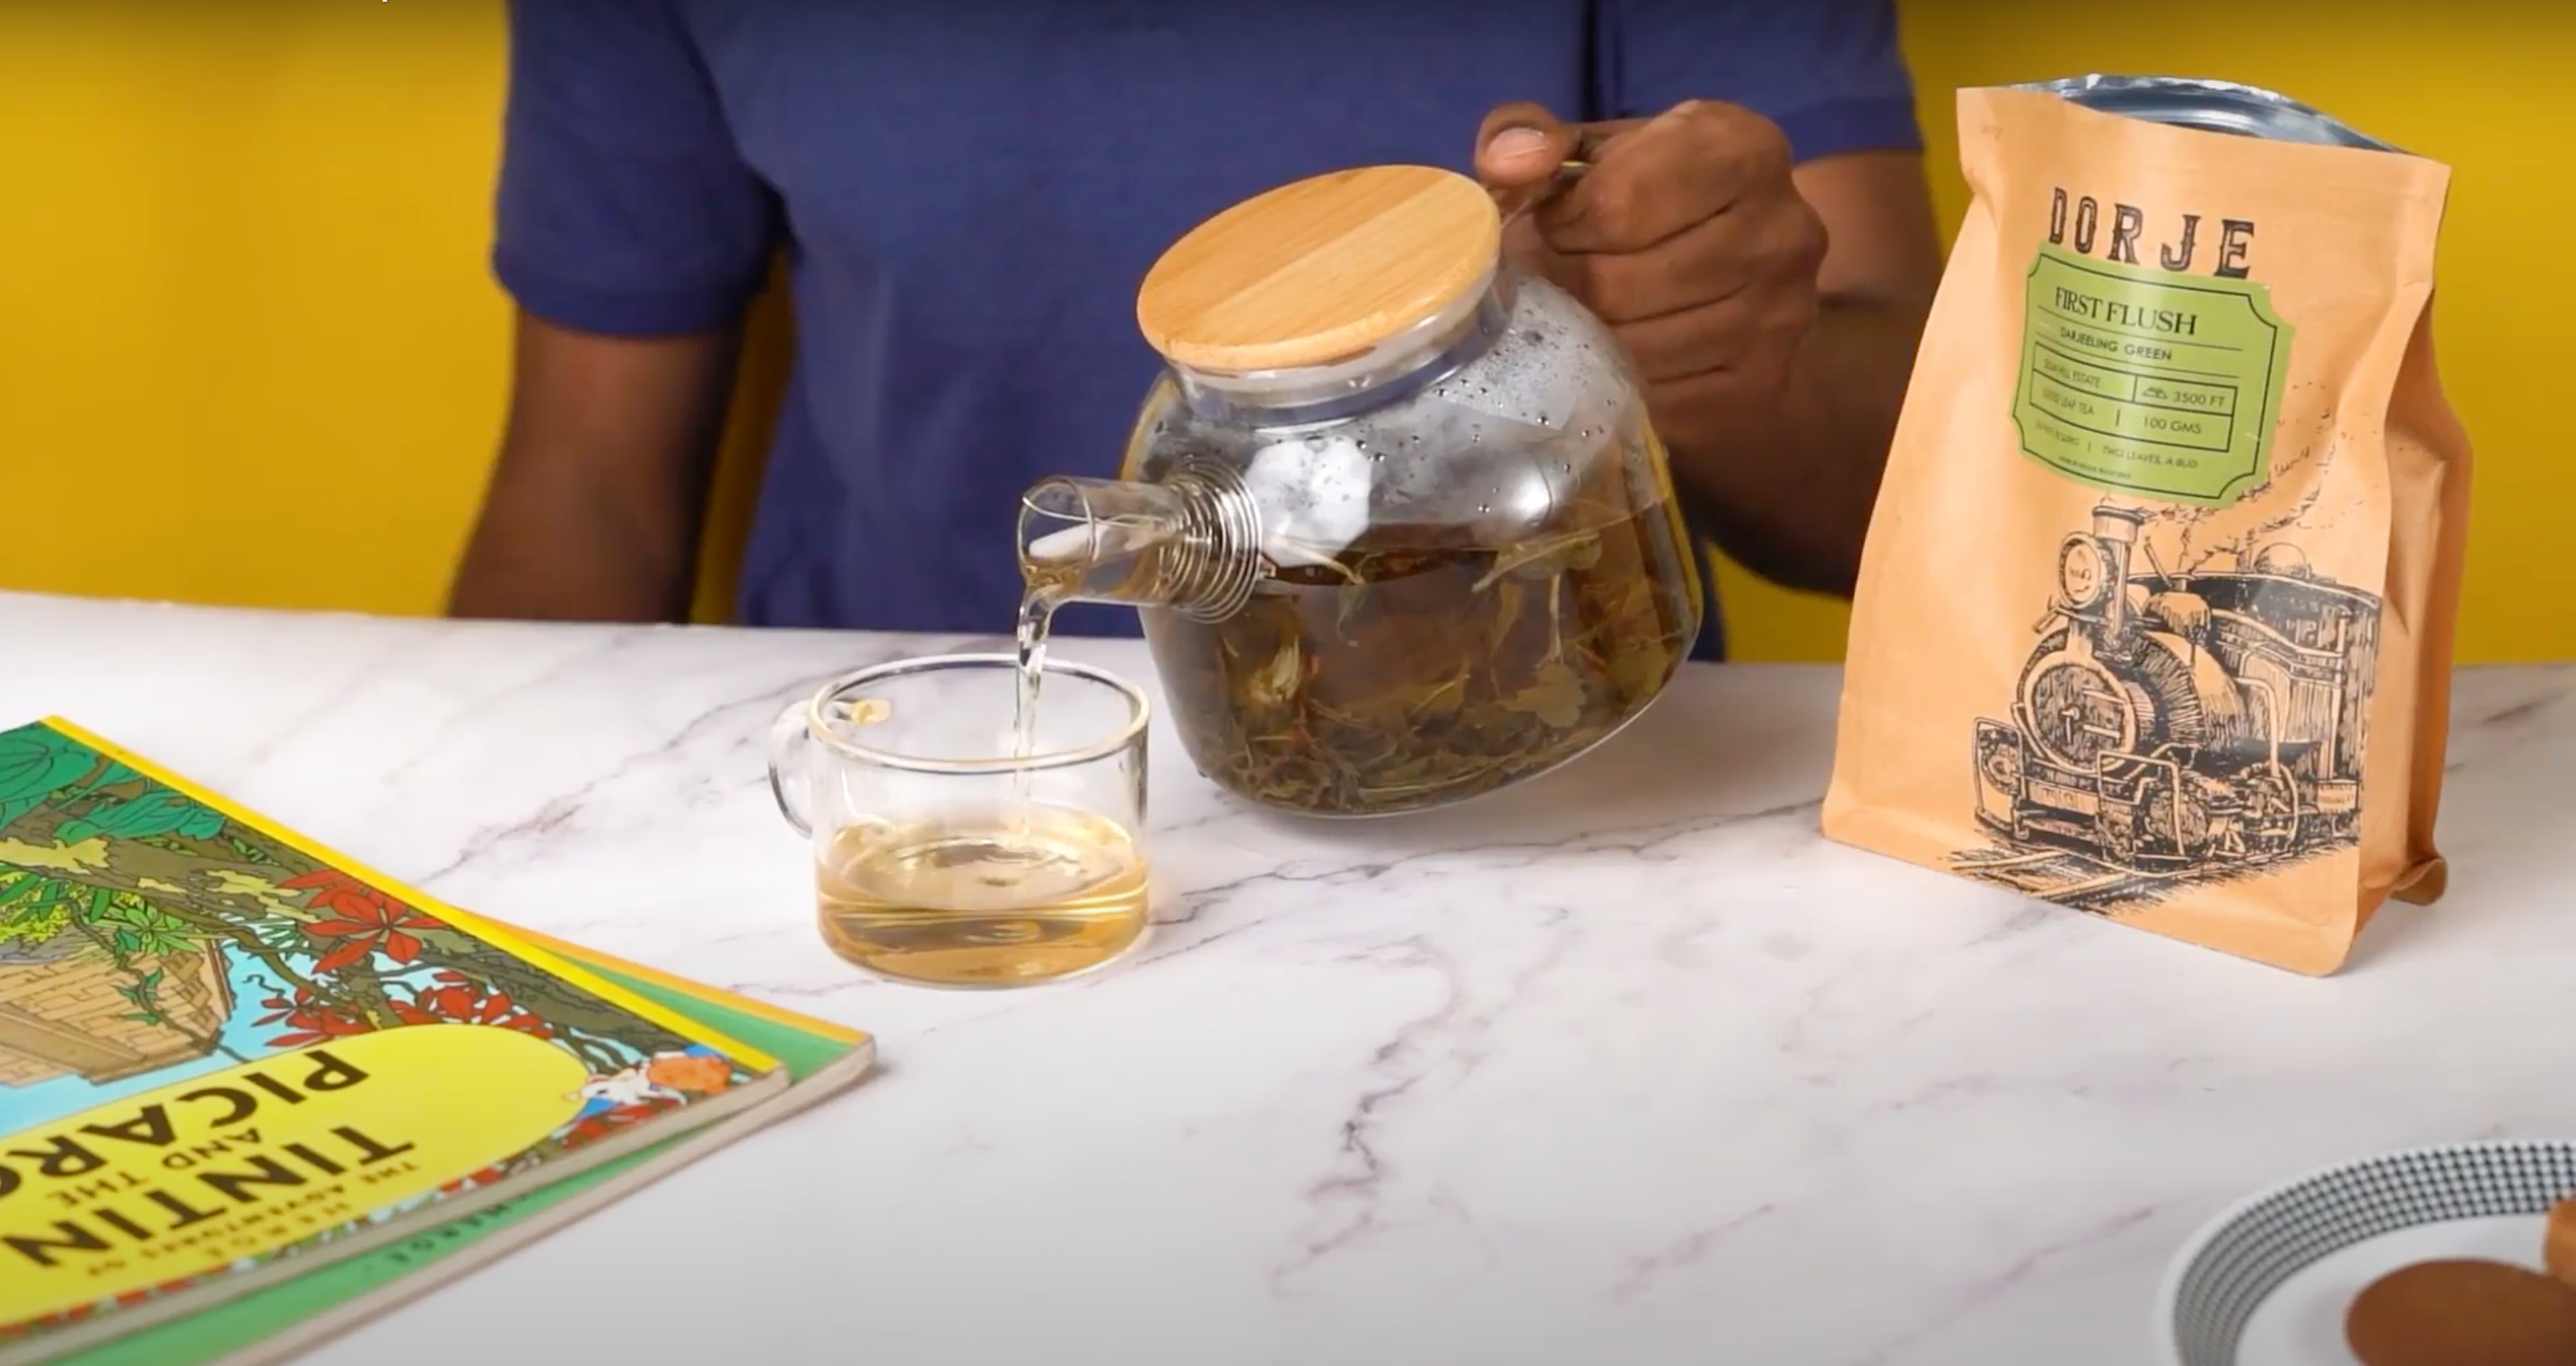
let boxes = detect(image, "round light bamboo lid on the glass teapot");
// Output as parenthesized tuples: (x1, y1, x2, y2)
(1136, 165, 1502, 372)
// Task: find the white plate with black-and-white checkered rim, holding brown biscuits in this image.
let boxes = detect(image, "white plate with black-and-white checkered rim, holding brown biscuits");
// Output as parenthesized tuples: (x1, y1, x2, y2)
(2156, 1139, 2576, 1366)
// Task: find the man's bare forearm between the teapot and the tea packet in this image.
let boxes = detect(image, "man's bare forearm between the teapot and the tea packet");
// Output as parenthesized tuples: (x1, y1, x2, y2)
(1667, 296, 1927, 598)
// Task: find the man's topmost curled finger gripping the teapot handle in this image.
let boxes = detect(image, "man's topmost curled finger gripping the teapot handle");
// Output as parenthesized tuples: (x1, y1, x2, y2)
(1536, 101, 1791, 252)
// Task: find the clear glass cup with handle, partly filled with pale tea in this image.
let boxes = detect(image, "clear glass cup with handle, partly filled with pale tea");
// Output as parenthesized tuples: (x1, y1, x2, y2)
(770, 654, 1146, 987)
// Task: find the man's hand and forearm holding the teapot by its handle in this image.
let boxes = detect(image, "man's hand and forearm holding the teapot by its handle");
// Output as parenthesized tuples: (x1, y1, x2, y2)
(1476, 101, 1940, 592)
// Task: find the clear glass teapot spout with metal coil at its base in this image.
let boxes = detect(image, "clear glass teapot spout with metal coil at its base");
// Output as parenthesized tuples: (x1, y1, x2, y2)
(1021, 469, 1262, 621)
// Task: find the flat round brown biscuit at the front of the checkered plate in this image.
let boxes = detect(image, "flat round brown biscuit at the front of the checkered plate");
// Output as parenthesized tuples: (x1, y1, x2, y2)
(2344, 1257, 2576, 1366)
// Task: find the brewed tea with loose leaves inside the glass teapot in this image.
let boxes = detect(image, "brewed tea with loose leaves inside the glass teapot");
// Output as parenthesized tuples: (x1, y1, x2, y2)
(1146, 486, 1697, 814)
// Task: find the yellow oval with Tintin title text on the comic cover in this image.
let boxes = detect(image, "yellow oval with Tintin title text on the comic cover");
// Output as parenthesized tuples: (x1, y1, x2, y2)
(0, 1023, 590, 1325)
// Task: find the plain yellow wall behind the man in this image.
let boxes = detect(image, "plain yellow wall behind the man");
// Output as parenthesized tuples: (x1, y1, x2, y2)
(0, 0, 2576, 660)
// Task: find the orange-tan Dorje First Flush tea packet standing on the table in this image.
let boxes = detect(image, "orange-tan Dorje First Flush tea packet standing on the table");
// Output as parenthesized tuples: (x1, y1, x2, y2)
(1824, 77, 2470, 975)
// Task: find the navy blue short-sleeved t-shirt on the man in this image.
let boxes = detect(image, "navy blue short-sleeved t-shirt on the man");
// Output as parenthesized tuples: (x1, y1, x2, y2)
(492, 0, 1922, 657)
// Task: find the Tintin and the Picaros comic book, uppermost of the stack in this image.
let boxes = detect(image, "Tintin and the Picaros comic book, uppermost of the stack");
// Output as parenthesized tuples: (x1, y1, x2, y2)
(0, 719, 871, 1366)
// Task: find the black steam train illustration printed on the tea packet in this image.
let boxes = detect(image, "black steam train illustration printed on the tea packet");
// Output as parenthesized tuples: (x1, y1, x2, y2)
(1976, 505, 2380, 874)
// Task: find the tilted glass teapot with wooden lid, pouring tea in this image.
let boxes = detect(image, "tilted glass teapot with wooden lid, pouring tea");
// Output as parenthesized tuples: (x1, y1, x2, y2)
(1021, 165, 1703, 817)
